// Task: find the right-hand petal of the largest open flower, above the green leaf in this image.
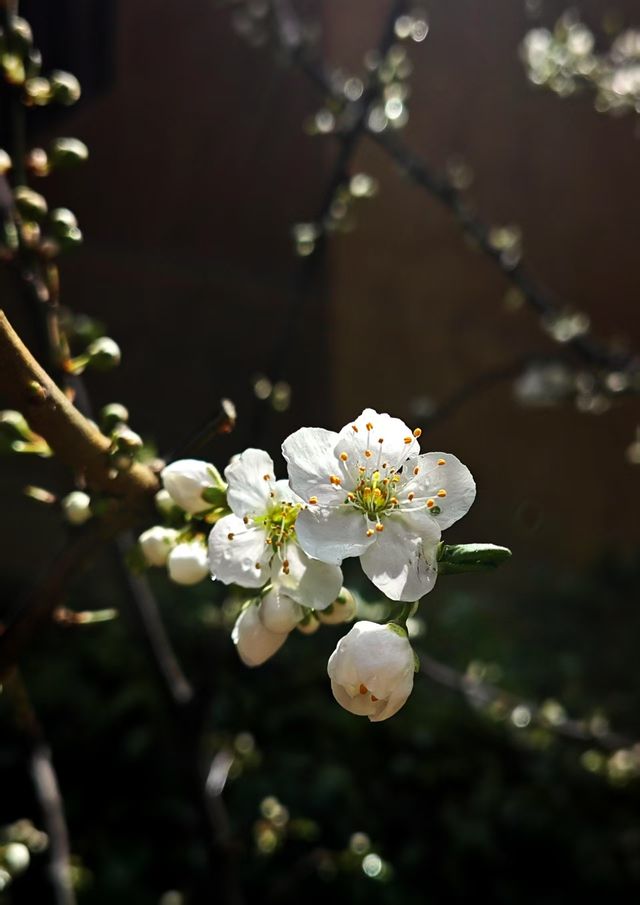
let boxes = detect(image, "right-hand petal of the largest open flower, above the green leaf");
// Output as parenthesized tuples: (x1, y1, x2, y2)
(402, 452, 476, 531)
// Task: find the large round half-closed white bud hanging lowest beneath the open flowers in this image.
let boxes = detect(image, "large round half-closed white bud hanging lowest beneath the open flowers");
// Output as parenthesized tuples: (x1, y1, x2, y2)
(327, 621, 415, 723)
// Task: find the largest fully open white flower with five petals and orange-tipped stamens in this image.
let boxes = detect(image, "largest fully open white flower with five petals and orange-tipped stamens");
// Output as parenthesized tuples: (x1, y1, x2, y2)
(282, 409, 476, 601)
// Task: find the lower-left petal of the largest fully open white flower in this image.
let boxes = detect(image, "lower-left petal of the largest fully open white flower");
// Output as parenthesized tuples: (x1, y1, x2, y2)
(296, 506, 374, 565)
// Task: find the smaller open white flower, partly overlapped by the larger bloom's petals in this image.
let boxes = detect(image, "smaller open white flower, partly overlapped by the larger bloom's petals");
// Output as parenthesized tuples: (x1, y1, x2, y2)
(209, 449, 342, 609)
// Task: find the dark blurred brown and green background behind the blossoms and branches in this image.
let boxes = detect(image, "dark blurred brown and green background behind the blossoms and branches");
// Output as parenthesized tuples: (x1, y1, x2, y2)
(0, 0, 640, 905)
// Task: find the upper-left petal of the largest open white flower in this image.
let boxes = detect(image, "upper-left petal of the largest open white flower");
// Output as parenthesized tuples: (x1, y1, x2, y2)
(282, 427, 350, 506)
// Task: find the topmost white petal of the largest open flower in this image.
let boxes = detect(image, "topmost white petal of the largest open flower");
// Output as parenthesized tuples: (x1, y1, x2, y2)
(336, 409, 420, 470)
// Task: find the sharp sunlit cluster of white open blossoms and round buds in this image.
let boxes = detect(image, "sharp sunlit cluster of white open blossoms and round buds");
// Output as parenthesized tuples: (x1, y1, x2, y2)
(139, 409, 475, 721)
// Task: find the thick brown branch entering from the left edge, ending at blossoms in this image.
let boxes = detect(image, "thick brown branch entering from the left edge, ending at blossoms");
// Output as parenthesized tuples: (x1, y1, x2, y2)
(0, 311, 158, 508)
